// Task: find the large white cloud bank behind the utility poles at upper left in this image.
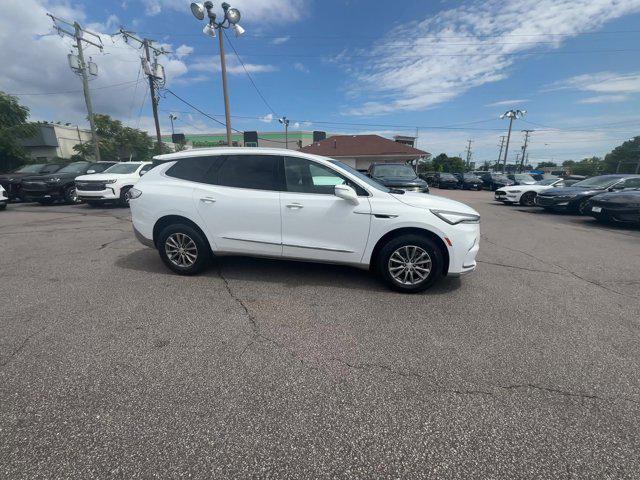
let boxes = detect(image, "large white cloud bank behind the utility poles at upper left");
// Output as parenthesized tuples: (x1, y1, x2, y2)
(0, 0, 187, 131)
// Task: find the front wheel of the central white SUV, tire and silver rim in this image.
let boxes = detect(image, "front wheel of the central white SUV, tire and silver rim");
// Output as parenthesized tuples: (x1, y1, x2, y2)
(376, 234, 444, 293)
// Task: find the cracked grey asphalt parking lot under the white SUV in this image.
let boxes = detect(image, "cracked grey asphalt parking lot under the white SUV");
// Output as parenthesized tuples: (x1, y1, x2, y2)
(0, 189, 640, 479)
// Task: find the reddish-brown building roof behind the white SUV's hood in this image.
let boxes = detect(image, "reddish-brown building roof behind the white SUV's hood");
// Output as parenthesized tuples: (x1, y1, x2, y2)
(300, 135, 429, 157)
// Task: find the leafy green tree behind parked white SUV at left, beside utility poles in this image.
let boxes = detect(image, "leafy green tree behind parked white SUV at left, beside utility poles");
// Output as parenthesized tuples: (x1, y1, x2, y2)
(73, 114, 154, 161)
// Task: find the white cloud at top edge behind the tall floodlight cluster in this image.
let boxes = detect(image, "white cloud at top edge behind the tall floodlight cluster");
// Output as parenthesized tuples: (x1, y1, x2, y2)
(140, 0, 307, 24)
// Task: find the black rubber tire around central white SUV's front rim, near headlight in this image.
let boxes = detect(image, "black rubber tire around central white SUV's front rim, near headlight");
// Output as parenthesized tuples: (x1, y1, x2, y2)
(376, 234, 444, 293)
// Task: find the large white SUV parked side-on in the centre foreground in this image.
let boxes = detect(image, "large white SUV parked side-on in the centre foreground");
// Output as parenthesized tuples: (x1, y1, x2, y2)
(129, 148, 480, 292)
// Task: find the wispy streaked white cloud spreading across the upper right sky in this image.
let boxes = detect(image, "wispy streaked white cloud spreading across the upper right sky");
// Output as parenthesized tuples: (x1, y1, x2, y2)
(341, 0, 640, 115)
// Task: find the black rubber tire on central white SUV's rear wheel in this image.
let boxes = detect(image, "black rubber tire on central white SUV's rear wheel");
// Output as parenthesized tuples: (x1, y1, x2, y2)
(156, 223, 211, 275)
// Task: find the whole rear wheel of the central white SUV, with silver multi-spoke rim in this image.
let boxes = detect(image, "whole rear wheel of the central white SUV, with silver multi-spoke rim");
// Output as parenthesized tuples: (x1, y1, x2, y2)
(157, 224, 210, 275)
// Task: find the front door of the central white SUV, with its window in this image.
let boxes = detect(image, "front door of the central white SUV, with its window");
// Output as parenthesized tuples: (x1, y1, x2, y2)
(281, 157, 371, 263)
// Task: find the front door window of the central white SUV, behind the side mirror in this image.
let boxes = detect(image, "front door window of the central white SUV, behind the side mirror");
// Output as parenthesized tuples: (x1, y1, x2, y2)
(284, 157, 368, 196)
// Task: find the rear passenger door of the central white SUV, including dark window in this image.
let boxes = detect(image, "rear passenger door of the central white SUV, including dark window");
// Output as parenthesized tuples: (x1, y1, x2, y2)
(193, 154, 282, 256)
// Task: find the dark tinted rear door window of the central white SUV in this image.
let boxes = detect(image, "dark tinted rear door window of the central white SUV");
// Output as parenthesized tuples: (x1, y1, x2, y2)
(215, 155, 282, 191)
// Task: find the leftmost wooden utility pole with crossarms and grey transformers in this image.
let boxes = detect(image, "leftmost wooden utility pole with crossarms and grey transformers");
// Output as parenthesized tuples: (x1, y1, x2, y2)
(47, 13, 103, 162)
